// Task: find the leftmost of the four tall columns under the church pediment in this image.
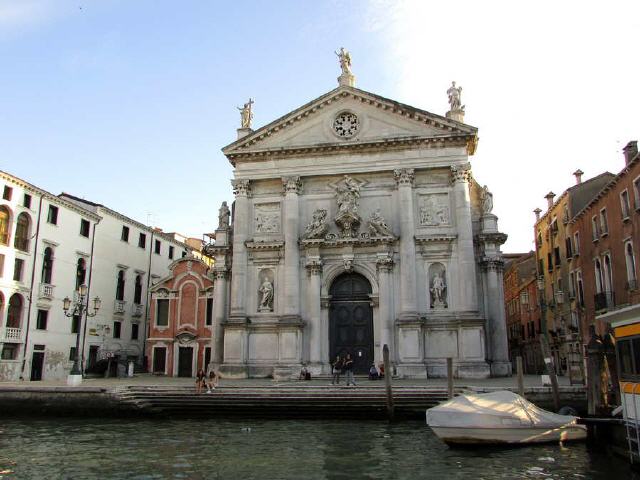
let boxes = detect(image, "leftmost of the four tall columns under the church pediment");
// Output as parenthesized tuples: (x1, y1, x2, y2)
(230, 179, 251, 319)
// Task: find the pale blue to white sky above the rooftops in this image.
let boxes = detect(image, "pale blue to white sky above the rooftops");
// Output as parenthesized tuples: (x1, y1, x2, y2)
(0, 0, 640, 252)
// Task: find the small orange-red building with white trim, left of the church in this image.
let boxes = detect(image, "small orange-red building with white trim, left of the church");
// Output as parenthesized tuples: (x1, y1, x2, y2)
(146, 256, 213, 377)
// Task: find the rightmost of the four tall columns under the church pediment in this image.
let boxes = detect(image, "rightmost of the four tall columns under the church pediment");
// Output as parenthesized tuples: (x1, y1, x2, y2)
(449, 164, 478, 311)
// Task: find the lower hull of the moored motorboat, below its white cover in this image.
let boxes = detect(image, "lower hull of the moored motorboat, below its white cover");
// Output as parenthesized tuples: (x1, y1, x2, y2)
(431, 425, 587, 445)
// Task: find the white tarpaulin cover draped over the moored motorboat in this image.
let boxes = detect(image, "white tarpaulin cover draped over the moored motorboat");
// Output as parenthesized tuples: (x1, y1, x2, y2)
(427, 390, 577, 428)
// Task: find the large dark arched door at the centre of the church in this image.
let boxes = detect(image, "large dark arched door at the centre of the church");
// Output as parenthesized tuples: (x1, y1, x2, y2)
(329, 273, 374, 373)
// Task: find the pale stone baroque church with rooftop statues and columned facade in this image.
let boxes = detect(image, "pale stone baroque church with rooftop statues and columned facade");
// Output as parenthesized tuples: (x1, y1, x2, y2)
(207, 49, 511, 378)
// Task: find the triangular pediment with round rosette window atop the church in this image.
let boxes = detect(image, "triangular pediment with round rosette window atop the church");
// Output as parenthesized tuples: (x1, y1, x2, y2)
(222, 86, 477, 159)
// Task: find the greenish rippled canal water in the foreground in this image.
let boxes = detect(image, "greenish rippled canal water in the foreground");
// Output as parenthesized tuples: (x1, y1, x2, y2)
(0, 418, 640, 480)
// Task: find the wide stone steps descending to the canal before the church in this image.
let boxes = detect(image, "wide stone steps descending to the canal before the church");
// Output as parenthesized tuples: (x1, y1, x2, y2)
(112, 382, 452, 418)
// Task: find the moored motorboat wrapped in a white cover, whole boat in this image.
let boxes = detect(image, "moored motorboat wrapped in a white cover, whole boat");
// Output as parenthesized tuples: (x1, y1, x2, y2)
(427, 390, 587, 445)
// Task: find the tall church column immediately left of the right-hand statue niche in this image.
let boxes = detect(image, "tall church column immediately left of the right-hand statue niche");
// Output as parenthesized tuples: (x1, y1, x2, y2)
(393, 168, 418, 320)
